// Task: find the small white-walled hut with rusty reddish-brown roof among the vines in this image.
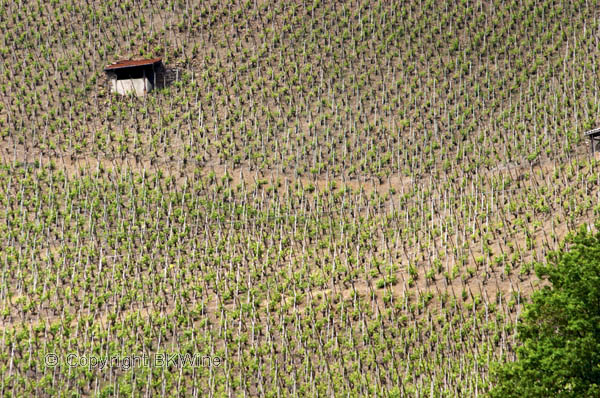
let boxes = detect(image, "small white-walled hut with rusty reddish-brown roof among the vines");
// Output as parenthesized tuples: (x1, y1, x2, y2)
(104, 58, 162, 96)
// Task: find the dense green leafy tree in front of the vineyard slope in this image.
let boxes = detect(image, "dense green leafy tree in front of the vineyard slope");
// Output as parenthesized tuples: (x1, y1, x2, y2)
(490, 227, 600, 398)
